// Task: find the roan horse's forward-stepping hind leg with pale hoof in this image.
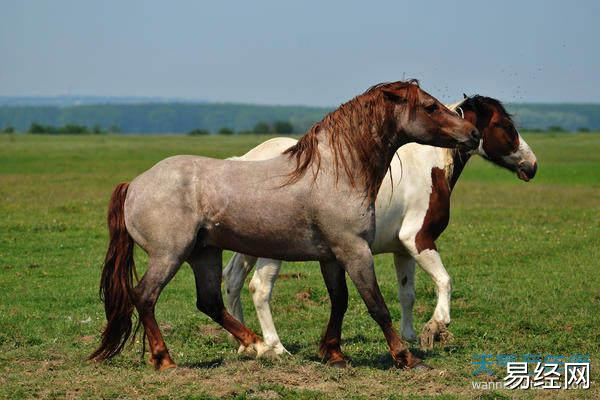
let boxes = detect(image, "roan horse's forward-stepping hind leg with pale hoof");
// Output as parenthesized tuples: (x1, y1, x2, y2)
(187, 247, 268, 356)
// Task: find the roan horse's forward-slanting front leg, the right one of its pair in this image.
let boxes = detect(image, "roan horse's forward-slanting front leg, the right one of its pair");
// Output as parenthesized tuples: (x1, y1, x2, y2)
(336, 240, 421, 368)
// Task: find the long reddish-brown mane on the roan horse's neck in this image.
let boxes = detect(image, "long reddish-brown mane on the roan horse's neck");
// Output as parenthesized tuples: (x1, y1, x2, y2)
(284, 80, 419, 198)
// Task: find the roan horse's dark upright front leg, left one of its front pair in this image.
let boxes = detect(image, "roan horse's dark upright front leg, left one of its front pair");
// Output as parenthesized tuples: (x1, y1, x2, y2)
(319, 262, 348, 368)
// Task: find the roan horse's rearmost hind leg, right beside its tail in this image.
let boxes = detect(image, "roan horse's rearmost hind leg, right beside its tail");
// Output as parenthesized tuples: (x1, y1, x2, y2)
(134, 256, 181, 370)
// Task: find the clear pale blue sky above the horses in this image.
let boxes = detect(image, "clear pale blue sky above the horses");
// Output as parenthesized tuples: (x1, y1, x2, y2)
(0, 0, 600, 106)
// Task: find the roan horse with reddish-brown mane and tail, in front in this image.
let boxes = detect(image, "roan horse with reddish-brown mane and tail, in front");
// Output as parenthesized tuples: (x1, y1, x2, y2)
(90, 81, 480, 370)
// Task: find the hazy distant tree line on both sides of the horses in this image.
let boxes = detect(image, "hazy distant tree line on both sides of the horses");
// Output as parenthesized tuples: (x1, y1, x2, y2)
(0, 103, 600, 134)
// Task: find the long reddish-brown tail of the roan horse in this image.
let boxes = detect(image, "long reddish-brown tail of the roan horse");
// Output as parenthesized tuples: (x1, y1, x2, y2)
(89, 182, 139, 360)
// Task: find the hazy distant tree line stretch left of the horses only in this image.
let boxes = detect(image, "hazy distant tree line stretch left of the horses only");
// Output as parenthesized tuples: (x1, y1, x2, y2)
(0, 103, 330, 133)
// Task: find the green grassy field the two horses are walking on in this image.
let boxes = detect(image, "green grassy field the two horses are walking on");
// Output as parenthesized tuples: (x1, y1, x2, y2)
(0, 134, 600, 398)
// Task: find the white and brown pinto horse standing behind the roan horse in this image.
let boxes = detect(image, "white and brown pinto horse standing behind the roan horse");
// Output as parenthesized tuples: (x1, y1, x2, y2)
(223, 95, 537, 354)
